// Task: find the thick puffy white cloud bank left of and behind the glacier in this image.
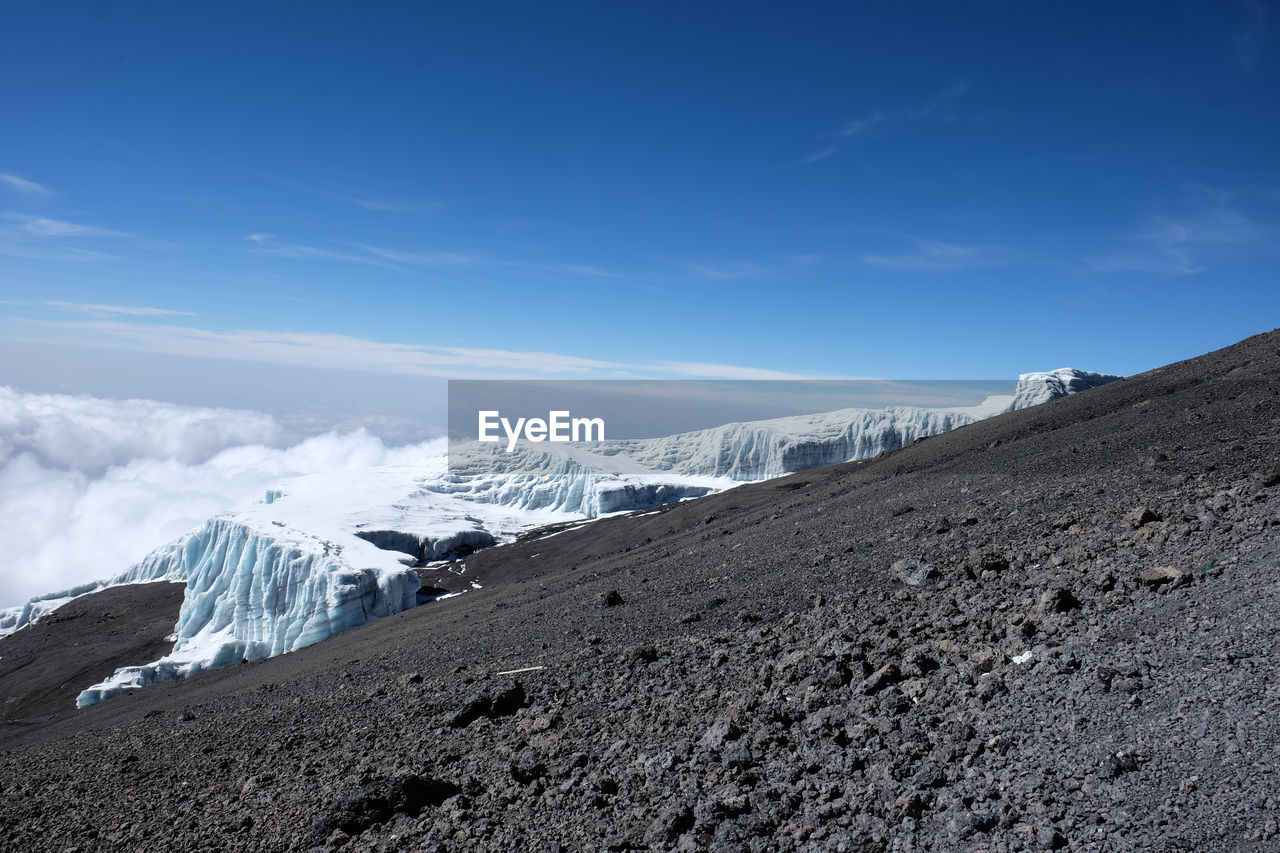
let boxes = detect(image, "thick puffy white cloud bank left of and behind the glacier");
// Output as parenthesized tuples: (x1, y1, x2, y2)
(0, 387, 444, 607)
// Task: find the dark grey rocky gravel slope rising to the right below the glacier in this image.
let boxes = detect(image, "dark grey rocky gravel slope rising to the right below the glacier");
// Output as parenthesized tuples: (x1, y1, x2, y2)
(0, 333, 1280, 850)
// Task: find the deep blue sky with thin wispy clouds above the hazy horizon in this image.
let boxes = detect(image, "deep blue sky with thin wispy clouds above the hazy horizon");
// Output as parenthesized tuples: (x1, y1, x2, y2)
(0, 0, 1280, 384)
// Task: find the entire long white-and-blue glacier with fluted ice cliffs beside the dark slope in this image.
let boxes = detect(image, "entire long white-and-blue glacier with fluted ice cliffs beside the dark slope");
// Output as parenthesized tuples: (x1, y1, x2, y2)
(0, 369, 1119, 707)
